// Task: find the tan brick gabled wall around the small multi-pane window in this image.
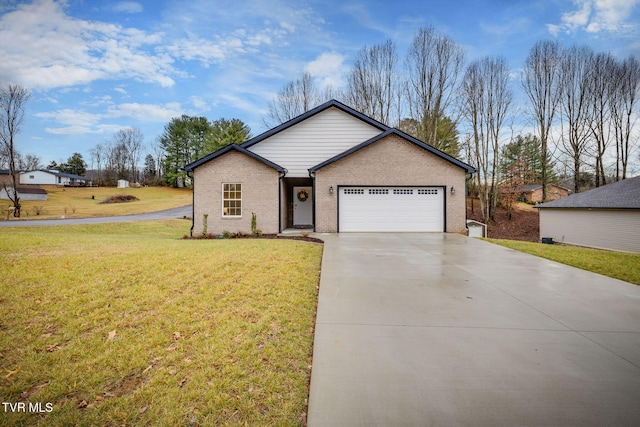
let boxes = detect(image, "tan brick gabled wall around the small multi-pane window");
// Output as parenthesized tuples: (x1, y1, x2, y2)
(193, 151, 280, 236)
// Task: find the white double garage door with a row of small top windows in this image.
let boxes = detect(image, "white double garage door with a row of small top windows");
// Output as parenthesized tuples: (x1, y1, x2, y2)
(338, 187, 444, 232)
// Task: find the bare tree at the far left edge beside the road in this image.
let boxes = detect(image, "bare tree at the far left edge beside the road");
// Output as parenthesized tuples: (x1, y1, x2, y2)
(0, 84, 31, 218)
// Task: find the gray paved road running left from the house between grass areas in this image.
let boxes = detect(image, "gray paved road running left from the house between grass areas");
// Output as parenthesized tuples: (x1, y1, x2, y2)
(0, 205, 193, 227)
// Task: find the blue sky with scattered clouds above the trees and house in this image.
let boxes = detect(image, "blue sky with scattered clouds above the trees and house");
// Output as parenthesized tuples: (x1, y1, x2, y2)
(0, 0, 640, 166)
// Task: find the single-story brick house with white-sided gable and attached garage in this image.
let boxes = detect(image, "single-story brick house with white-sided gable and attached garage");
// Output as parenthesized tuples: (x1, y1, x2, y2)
(184, 101, 475, 236)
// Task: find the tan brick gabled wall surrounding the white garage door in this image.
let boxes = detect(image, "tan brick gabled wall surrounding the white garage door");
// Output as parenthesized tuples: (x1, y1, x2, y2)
(316, 135, 466, 233)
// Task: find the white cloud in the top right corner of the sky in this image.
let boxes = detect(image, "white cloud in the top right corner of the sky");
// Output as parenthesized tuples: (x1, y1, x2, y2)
(547, 0, 640, 36)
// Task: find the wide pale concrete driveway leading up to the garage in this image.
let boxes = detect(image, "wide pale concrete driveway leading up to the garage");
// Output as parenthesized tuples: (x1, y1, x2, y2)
(308, 234, 640, 427)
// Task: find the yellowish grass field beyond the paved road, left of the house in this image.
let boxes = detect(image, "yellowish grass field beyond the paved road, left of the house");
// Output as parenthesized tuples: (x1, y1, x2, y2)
(0, 185, 193, 220)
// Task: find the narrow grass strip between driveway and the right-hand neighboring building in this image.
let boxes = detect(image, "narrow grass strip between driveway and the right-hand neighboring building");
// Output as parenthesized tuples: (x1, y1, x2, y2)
(487, 239, 640, 285)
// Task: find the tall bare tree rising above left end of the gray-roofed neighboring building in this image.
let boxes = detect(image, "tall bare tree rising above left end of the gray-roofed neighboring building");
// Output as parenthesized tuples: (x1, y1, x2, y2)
(521, 40, 560, 200)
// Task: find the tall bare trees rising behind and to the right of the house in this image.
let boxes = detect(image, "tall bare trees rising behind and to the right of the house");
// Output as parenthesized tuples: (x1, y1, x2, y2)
(264, 27, 640, 220)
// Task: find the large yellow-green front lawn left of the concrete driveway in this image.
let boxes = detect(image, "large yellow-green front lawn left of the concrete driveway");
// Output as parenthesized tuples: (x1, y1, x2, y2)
(0, 220, 322, 426)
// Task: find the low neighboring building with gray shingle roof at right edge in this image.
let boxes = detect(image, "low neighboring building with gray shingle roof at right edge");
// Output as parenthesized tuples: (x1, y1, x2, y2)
(538, 177, 640, 252)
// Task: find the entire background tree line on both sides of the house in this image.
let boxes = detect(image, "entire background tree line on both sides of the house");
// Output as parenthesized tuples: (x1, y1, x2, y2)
(0, 27, 640, 220)
